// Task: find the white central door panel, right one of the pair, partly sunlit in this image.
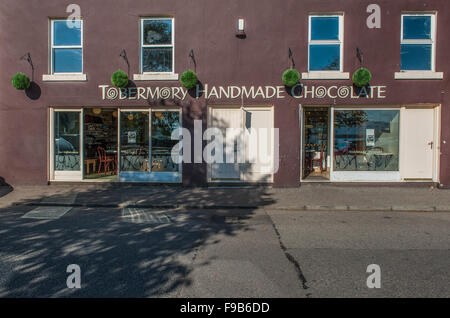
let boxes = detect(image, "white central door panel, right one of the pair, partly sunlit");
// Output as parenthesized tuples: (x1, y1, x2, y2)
(241, 108, 274, 182)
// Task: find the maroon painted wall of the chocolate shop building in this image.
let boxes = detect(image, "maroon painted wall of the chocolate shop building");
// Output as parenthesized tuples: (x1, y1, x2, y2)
(0, 0, 450, 186)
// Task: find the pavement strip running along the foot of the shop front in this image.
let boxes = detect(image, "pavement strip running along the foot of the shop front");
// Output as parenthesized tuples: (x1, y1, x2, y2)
(0, 184, 450, 212)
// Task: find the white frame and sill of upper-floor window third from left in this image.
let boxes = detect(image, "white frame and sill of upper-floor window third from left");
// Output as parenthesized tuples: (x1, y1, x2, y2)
(302, 13, 349, 79)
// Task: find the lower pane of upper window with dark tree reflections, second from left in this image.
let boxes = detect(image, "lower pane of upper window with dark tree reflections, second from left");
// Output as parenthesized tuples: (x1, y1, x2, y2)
(142, 47, 172, 72)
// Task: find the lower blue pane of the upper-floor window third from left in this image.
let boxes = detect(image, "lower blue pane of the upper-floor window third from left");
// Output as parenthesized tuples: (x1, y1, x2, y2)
(309, 44, 341, 71)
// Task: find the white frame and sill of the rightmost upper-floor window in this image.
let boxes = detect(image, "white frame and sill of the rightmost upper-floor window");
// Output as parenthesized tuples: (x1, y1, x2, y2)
(394, 12, 444, 79)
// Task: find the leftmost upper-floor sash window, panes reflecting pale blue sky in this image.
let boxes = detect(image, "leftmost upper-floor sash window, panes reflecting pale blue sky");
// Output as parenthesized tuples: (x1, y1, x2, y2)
(50, 20, 83, 74)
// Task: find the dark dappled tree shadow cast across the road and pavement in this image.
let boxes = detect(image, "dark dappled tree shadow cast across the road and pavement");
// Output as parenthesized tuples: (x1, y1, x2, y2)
(0, 184, 273, 297)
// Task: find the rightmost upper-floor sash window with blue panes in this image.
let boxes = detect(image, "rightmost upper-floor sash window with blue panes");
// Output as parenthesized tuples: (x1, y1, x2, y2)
(400, 14, 436, 71)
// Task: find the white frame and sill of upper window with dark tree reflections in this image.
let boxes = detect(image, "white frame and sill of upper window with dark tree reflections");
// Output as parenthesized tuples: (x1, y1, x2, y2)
(133, 17, 178, 81)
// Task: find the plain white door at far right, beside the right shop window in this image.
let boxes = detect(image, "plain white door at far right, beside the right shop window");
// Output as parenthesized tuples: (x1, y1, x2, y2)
(403, 108, 436, 179)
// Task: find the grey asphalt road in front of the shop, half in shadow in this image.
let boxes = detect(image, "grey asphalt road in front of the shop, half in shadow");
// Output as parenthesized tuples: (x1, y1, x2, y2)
(0, 206, 450, 298)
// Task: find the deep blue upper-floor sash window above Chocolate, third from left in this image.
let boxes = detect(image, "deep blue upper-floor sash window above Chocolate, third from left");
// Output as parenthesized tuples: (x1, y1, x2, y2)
(309, 15, 344, 72)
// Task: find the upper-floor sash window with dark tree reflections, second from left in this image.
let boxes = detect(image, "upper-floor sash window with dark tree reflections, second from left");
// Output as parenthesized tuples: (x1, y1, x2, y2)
(141, 18, 174, 74)
